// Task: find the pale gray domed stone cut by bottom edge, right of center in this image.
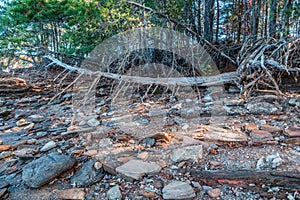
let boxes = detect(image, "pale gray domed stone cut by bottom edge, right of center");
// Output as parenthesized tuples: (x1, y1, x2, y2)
(162, 181, 196, 199)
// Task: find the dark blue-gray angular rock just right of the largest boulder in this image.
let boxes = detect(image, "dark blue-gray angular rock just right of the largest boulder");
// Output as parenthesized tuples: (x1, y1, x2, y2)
(71, 159, 104, 187)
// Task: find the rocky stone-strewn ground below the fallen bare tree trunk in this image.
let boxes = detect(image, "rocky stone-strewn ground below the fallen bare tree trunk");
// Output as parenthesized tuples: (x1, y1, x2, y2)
(0, 70, 300, 200)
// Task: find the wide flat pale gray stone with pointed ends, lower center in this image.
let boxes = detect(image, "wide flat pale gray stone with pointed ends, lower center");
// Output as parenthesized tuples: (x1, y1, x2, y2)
(116, 160, 161, 181)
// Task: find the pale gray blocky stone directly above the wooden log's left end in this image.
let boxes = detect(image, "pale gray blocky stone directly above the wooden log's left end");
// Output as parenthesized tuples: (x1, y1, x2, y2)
(170, 145, 203, 162)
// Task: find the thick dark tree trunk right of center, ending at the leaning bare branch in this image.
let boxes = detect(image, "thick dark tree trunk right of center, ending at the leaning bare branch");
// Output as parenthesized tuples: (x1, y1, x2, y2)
(204, 0, 214, 42)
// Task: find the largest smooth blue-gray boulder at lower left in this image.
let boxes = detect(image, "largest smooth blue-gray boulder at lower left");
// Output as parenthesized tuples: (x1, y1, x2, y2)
(22, 152, 75, 188)
